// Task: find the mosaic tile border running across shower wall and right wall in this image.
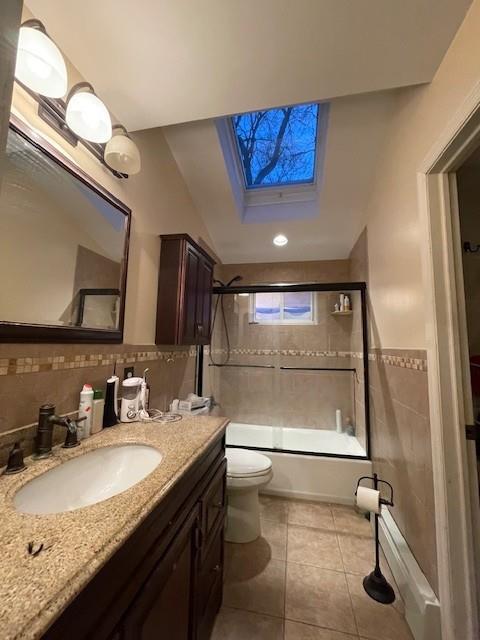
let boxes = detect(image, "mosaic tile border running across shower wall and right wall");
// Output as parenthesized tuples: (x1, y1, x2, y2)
(205, 347, 427, 371)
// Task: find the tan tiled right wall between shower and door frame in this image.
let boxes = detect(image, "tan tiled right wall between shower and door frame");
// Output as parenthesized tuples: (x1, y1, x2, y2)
(350, 230, 438, 593)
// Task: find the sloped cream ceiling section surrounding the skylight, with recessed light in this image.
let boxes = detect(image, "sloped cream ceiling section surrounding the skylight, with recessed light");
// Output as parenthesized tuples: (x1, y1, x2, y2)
(164, 91, 395, 263)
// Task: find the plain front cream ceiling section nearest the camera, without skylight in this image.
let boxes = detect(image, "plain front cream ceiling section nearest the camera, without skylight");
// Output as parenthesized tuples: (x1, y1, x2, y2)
(26, 0, 471, 130)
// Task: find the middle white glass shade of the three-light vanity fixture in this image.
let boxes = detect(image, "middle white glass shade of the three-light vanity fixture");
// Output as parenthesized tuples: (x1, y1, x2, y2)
(65, 82, 112, 143)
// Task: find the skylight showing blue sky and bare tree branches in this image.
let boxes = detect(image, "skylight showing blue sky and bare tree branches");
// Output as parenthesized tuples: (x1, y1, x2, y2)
(231, 104, 318, 189)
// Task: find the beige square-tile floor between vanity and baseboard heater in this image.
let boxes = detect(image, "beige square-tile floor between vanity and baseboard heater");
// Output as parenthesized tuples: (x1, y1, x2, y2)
(211, 496, 412, 640)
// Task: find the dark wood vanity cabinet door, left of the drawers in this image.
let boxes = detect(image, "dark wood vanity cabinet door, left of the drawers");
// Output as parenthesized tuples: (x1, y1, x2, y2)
(121, 509, 198, 640)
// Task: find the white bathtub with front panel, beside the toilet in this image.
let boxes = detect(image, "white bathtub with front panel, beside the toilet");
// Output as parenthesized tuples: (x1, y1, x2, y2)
(226, 422, 372, 504)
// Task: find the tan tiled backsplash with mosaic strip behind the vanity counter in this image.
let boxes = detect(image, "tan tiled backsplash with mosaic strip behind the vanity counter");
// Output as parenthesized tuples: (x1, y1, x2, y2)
(0, 344, 195, 466)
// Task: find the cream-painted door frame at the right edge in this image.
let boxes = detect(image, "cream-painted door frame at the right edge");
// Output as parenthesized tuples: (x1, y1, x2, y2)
(417, 83, 480, 640)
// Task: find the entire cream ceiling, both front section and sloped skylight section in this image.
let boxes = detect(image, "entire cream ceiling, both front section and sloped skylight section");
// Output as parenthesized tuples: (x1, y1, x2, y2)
(26, 0, 471, 263)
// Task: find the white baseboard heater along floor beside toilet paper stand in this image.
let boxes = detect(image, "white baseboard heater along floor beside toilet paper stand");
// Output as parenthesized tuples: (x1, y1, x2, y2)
(379, 506, 442, 640)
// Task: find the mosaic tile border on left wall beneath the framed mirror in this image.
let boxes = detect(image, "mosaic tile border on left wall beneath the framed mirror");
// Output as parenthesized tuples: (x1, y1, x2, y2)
(0, 347, 196, 376)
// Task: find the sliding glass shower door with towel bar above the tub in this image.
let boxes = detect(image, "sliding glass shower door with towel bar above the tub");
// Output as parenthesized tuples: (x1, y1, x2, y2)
(204, 290, 366, 457)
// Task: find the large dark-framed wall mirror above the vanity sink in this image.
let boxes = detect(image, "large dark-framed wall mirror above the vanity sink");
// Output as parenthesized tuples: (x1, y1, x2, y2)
(0, 118, 130, 342)
